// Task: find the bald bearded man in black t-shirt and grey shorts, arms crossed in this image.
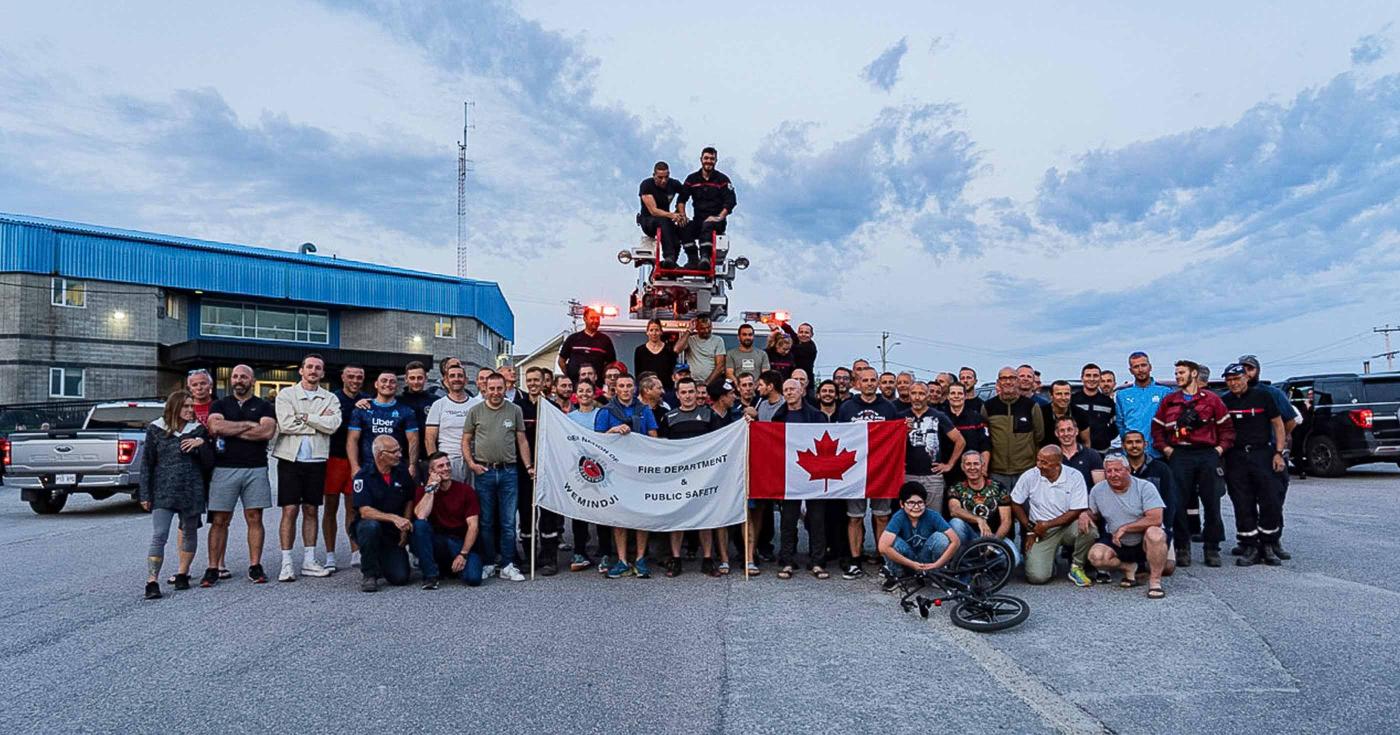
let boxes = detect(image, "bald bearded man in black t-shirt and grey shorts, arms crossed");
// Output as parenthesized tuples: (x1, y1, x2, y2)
(204, 365, 277, 587)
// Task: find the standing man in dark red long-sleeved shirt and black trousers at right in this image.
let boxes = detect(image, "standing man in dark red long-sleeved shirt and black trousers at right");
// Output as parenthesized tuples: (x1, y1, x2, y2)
(1152, 360, 1235, 567)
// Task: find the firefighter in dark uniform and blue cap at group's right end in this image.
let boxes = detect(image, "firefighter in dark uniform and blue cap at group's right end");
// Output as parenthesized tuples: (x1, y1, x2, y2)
(1221, 363, 1284, 567)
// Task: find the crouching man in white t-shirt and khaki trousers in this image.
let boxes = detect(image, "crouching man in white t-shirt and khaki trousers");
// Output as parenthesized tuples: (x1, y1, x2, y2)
(1011, 447, 1099, 587)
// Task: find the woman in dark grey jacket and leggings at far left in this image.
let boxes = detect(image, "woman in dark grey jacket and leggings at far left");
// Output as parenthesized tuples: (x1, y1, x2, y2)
(137, 391, 214, 599)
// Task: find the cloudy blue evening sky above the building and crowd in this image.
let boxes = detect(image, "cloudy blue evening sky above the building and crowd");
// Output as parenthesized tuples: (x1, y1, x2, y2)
(0, 0, 1400, 377)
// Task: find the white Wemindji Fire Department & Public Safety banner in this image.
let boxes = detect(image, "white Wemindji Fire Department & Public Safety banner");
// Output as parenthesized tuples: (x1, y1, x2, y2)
(535, 400, 749, 531)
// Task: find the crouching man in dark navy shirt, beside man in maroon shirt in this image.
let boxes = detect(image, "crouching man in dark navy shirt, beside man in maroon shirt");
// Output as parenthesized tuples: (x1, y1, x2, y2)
(353, 434, 417, 592)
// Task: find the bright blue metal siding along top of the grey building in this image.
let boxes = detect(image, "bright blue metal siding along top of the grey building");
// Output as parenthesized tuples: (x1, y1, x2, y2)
(0, 213, 515, 340)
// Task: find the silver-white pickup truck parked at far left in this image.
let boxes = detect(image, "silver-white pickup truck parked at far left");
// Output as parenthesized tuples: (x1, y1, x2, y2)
(4, 400, 165, 515)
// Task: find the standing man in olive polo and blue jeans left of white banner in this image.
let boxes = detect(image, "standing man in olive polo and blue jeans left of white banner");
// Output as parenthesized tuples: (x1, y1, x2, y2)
(462, 372, 535, 582)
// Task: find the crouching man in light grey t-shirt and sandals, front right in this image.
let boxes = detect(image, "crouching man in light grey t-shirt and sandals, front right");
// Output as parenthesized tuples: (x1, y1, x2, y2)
(1089, 452, 1166, 599)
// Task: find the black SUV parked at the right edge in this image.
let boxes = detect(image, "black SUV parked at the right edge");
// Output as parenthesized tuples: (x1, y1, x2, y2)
(1277, 372, 1400, 477)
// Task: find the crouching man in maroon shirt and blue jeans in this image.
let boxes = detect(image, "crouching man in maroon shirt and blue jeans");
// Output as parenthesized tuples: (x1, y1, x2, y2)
(413, 452, 482, 589)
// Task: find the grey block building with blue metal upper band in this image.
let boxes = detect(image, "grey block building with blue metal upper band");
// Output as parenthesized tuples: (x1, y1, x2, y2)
(0, 213, 515, 403)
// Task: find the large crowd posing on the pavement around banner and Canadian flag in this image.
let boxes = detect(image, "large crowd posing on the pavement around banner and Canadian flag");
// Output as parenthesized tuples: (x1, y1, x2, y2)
(140, 309, 1298, 598)
